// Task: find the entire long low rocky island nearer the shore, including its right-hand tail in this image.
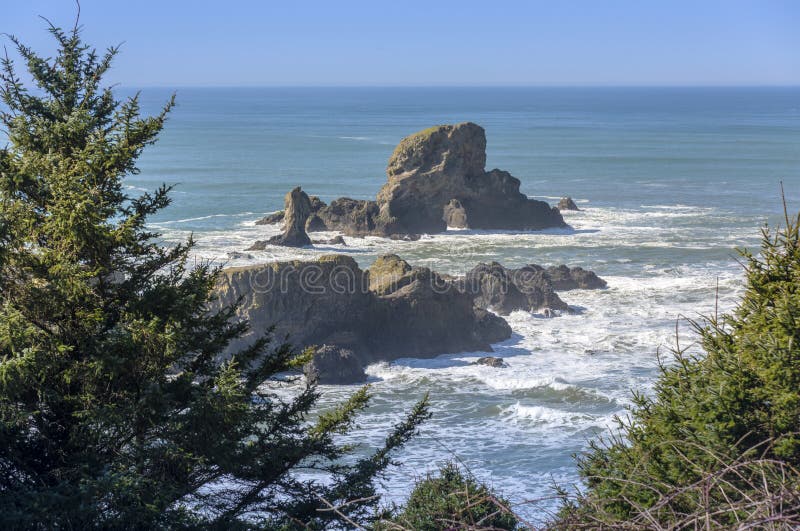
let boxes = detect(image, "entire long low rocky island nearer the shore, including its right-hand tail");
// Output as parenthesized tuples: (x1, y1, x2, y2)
(217, 254, 605, 383)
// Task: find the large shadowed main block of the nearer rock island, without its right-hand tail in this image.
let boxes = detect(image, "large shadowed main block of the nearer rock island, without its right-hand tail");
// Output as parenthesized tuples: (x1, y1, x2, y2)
(217, 255, 511, 372)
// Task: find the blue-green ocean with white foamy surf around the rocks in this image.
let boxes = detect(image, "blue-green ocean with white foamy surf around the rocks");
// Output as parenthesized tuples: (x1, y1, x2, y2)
(121, 88, 800, 520)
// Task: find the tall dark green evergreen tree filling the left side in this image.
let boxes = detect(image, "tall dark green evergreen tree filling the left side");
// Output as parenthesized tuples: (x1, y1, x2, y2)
(0, 18, 427, 529)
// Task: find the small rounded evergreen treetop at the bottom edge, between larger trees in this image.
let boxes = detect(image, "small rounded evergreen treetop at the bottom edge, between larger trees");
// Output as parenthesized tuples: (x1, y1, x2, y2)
(378, 463, 518, 531)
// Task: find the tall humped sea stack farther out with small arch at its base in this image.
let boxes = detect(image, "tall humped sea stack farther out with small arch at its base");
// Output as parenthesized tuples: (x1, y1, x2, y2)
(256, 122, 566, 236)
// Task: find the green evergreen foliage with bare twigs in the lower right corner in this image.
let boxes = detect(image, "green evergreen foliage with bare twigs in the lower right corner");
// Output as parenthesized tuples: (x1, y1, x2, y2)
(555, 204, 800, 529)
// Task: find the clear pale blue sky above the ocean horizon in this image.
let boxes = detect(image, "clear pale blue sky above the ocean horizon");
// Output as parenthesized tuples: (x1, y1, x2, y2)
(0, 0, 800, 87)
